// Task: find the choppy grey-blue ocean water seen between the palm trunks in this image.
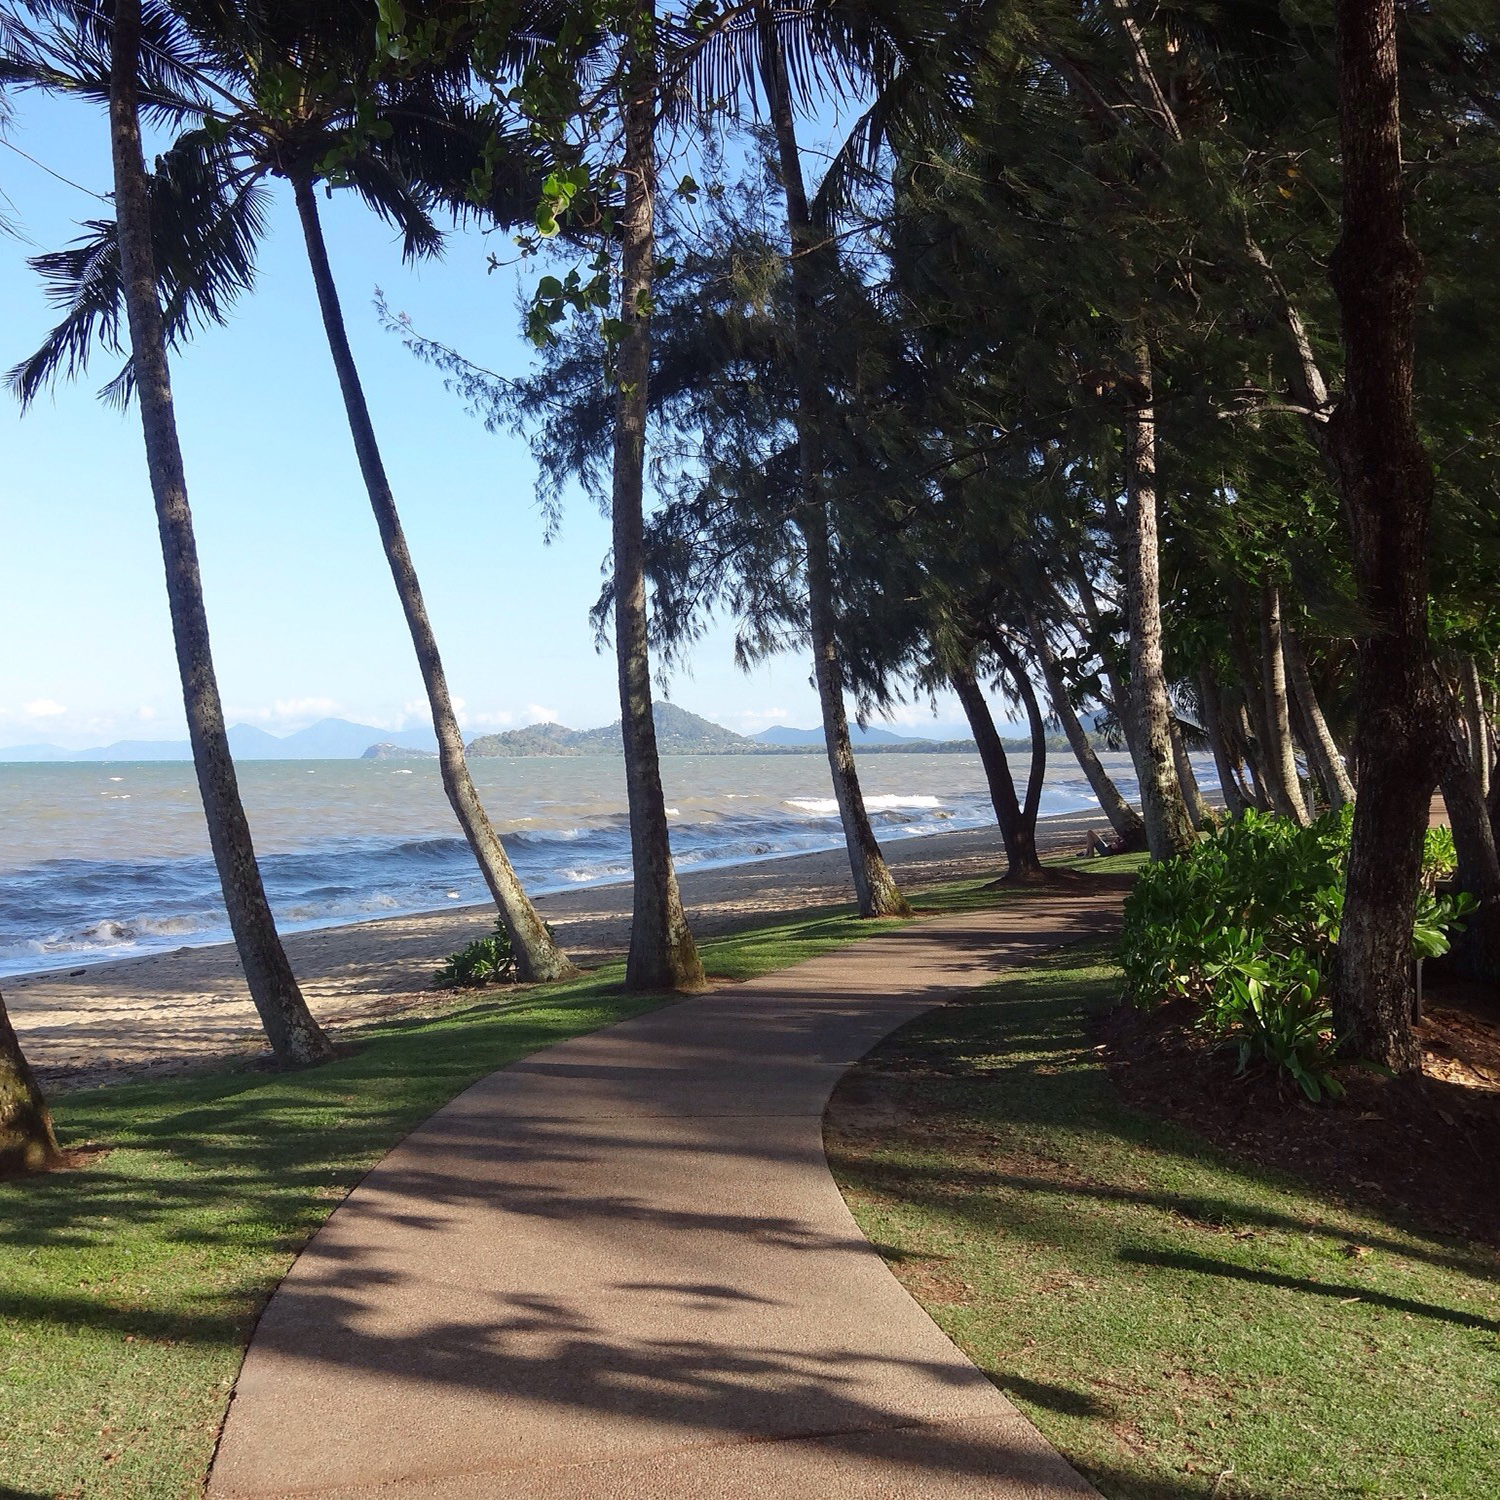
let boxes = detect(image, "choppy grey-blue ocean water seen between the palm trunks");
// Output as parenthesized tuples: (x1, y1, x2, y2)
(0, 755, 1194, 975)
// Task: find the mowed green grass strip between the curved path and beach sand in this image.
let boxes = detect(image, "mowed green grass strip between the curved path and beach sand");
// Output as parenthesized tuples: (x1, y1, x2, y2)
(0, 914, 888, 1500)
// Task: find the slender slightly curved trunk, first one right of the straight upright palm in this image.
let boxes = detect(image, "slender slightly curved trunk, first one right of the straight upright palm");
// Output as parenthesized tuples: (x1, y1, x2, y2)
(758, 6, 911, 917)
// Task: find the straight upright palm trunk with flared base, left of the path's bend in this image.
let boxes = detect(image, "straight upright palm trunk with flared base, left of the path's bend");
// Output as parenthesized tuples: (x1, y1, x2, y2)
(611, 11, 707, 990)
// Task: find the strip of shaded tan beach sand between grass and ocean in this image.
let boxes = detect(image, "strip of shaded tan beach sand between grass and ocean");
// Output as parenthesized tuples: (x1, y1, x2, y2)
(5, 813, 1106, 1092)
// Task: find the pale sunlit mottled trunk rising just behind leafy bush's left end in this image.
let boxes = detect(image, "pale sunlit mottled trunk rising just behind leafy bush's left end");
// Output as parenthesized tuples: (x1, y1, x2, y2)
(1124, 339, 1194, 860)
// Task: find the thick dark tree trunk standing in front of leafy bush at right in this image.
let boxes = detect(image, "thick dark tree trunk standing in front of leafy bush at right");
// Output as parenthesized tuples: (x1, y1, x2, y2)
(1329, 0, 1445, 1073)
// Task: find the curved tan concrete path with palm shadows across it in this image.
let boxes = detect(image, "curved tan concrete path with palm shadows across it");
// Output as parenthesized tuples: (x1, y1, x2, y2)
(209, 888, 1121, 1500)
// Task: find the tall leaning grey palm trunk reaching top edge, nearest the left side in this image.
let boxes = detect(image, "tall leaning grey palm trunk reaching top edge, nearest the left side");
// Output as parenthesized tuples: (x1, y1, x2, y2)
(110, 0, 333, 1064)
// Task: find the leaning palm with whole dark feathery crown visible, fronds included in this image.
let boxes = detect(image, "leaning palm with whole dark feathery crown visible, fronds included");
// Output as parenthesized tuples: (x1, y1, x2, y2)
(14, 3, 578, 981)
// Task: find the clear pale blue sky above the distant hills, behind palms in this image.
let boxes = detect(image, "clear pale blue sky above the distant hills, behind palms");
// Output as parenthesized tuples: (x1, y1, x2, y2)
(0, 96, 984, 747)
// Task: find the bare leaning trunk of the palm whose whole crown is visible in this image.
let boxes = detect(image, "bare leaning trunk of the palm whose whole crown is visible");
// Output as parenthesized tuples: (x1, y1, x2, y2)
(293, 176, 578, 981)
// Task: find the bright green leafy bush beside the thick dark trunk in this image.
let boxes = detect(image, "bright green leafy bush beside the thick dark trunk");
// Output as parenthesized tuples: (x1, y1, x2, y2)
(1122, 809, 1475, 1100)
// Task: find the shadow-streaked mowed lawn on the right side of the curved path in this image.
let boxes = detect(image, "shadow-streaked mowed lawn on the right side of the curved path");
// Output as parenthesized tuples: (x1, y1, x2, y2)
(830, 950, 1500, 1500)
